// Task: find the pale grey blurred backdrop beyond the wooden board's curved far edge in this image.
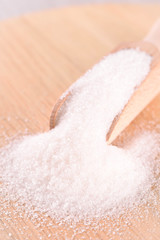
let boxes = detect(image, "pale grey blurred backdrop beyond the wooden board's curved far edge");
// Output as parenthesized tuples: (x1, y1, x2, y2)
(0, 0, 159, 20)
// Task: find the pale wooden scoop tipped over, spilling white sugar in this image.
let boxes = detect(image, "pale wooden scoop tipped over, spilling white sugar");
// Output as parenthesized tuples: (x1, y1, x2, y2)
(50, 20, 160, 144)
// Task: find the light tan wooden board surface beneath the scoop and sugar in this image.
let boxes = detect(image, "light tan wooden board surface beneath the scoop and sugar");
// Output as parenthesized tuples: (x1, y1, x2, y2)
(0, 5, 160, 240)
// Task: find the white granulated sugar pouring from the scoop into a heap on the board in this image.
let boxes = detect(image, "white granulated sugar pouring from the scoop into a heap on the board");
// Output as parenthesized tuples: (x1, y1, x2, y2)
(0, 49, 159, 225)
